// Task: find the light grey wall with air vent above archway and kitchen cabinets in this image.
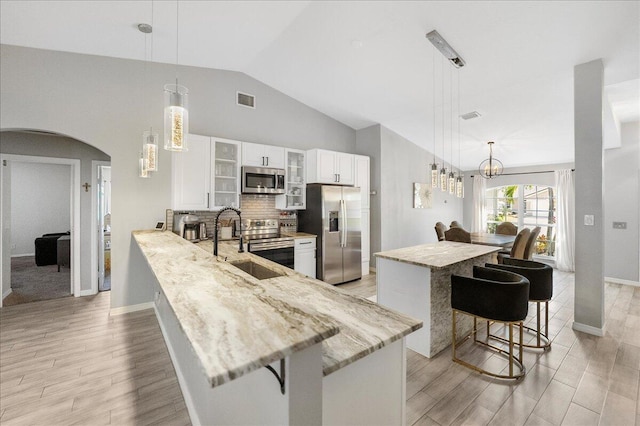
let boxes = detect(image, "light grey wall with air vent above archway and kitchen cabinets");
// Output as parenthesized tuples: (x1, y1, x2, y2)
(0, 45, 355, 308)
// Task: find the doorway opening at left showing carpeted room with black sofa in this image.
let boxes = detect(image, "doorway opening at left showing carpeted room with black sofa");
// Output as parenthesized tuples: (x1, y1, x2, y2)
(0, 154, 80, 306)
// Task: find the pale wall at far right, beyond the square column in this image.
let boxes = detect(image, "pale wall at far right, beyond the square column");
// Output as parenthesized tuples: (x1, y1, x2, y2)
(604, 121, 640, 282)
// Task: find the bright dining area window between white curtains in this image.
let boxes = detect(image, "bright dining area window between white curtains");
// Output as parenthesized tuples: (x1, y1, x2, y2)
(485, 185, 556, 257)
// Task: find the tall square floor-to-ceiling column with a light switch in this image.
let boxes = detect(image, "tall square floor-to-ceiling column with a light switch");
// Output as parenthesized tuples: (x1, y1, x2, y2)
(573, 59, 604, 336)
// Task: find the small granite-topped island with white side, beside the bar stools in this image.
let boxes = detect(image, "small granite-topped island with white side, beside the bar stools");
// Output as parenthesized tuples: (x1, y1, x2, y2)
(374, 241, 500, 357)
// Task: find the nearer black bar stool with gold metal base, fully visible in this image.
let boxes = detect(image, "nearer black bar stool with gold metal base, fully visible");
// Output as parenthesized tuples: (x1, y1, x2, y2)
(451, 266, 529, 379)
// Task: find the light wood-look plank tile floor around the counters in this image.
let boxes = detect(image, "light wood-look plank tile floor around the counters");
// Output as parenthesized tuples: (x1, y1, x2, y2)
(0, 271, 640, 426)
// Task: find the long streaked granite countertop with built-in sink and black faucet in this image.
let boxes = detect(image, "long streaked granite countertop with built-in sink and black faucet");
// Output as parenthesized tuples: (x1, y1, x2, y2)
(133, 231, 422, 386)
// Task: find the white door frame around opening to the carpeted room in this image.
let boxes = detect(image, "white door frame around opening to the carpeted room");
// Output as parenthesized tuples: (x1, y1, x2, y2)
(0, 154, 81, 307)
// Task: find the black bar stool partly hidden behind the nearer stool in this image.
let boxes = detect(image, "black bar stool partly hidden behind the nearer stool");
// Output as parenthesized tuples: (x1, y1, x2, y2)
(485, 258, 553, 351)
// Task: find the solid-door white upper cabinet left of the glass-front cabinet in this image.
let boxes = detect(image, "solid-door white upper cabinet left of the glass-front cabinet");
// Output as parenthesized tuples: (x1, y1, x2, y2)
(171, 135, 212, 210)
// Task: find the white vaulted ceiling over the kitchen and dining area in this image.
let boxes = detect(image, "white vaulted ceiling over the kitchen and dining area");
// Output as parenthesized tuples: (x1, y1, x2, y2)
(0, 0, 640, 170)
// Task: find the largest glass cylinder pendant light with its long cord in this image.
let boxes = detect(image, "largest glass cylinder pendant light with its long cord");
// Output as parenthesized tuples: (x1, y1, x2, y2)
(164, 0, 189, 152)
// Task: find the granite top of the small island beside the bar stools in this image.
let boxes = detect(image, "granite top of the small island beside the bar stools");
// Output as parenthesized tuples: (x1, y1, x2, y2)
(373, 241, 501, 269)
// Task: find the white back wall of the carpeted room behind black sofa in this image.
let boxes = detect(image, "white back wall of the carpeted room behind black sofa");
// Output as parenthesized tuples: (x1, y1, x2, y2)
(11, 162, 71, 256)
